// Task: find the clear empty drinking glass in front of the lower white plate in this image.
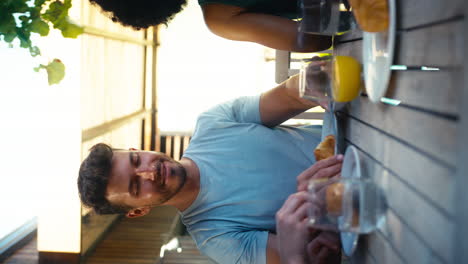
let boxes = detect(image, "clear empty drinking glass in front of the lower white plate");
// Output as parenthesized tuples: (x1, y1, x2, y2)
(308, 177, 386, 234)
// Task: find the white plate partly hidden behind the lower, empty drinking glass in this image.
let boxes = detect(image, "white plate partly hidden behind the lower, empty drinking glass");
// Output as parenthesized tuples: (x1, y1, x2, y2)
(338, 146, 362, 257)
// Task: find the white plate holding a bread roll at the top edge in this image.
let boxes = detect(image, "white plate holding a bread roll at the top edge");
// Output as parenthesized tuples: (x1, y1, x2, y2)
(362, 0, 396, 103)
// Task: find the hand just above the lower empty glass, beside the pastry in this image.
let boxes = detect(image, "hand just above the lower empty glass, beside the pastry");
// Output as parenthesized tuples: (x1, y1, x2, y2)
(297, 154, 343, 192)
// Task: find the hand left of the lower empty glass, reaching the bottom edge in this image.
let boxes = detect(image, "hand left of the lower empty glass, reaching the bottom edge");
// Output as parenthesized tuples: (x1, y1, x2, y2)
(276, 192, 311, 264)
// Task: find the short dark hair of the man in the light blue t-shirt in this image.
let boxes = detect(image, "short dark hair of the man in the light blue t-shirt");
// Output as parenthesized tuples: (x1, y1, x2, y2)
(78, 143, 132, 214)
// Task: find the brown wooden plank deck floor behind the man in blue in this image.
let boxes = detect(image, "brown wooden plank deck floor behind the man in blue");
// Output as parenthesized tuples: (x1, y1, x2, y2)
(4, 207, 214, 264)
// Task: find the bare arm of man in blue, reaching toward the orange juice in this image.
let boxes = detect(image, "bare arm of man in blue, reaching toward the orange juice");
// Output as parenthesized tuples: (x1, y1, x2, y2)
(260, 75, 318, 127)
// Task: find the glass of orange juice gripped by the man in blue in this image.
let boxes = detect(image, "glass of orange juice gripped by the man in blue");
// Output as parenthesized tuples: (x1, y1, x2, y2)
(299, 56, 361, 108)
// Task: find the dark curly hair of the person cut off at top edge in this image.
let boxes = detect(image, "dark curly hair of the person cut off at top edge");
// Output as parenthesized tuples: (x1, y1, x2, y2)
(90, 0, 187, 29)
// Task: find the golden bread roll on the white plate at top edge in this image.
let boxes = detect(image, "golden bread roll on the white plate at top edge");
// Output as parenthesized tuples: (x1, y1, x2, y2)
(349, 0, 389, 32)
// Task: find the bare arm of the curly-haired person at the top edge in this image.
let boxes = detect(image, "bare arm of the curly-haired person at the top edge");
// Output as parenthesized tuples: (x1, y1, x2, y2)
(202, 4, 331, 52)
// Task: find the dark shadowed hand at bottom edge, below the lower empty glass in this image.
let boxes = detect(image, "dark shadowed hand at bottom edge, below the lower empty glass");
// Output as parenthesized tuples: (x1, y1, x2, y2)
(307, 231, 341, 264)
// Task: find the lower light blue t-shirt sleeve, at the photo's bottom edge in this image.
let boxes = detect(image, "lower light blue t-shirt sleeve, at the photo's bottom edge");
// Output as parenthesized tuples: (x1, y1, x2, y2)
(199, 231, 268, 264)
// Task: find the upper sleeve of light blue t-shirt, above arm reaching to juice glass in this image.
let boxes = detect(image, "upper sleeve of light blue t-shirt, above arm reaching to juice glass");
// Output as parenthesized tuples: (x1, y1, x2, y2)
(199, 95, 261, 124)
